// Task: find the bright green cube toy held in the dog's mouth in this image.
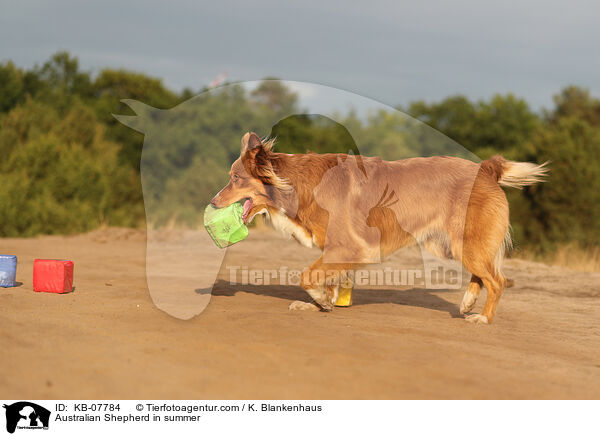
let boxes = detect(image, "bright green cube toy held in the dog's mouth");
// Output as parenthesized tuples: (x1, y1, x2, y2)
(204, 203, 248, 248)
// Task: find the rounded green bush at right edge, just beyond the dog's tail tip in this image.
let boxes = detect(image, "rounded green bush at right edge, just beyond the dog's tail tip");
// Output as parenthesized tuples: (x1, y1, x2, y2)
(521, 116, 600, 248)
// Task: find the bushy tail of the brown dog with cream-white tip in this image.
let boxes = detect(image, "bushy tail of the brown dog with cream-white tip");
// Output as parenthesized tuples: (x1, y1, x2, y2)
(481, 156, 550, 189)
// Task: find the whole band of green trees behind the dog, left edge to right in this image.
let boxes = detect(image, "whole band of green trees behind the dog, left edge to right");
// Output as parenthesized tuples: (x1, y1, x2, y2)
(0, 53, 600, 250)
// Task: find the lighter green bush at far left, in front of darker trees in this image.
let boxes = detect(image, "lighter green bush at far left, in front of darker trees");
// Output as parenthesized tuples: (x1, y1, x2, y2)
(0, 100, 143, 236)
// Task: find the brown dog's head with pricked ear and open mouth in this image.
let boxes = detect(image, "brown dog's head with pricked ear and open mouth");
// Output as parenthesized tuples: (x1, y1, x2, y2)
(211, 132, 288, 222)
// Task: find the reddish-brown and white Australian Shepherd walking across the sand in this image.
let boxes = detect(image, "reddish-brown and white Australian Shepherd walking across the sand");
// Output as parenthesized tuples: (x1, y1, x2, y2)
(212, 132, 547, 324)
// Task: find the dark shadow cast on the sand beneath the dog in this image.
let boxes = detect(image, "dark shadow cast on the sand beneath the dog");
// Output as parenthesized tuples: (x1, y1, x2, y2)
(212, 280, 462, 318)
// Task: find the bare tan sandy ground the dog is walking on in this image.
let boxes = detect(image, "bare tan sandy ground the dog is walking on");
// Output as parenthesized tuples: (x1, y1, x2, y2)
(0, 229, 600, 399)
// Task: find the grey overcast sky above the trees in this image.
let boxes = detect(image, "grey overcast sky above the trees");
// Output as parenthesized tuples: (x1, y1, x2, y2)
(0, 0, 600, 110)
